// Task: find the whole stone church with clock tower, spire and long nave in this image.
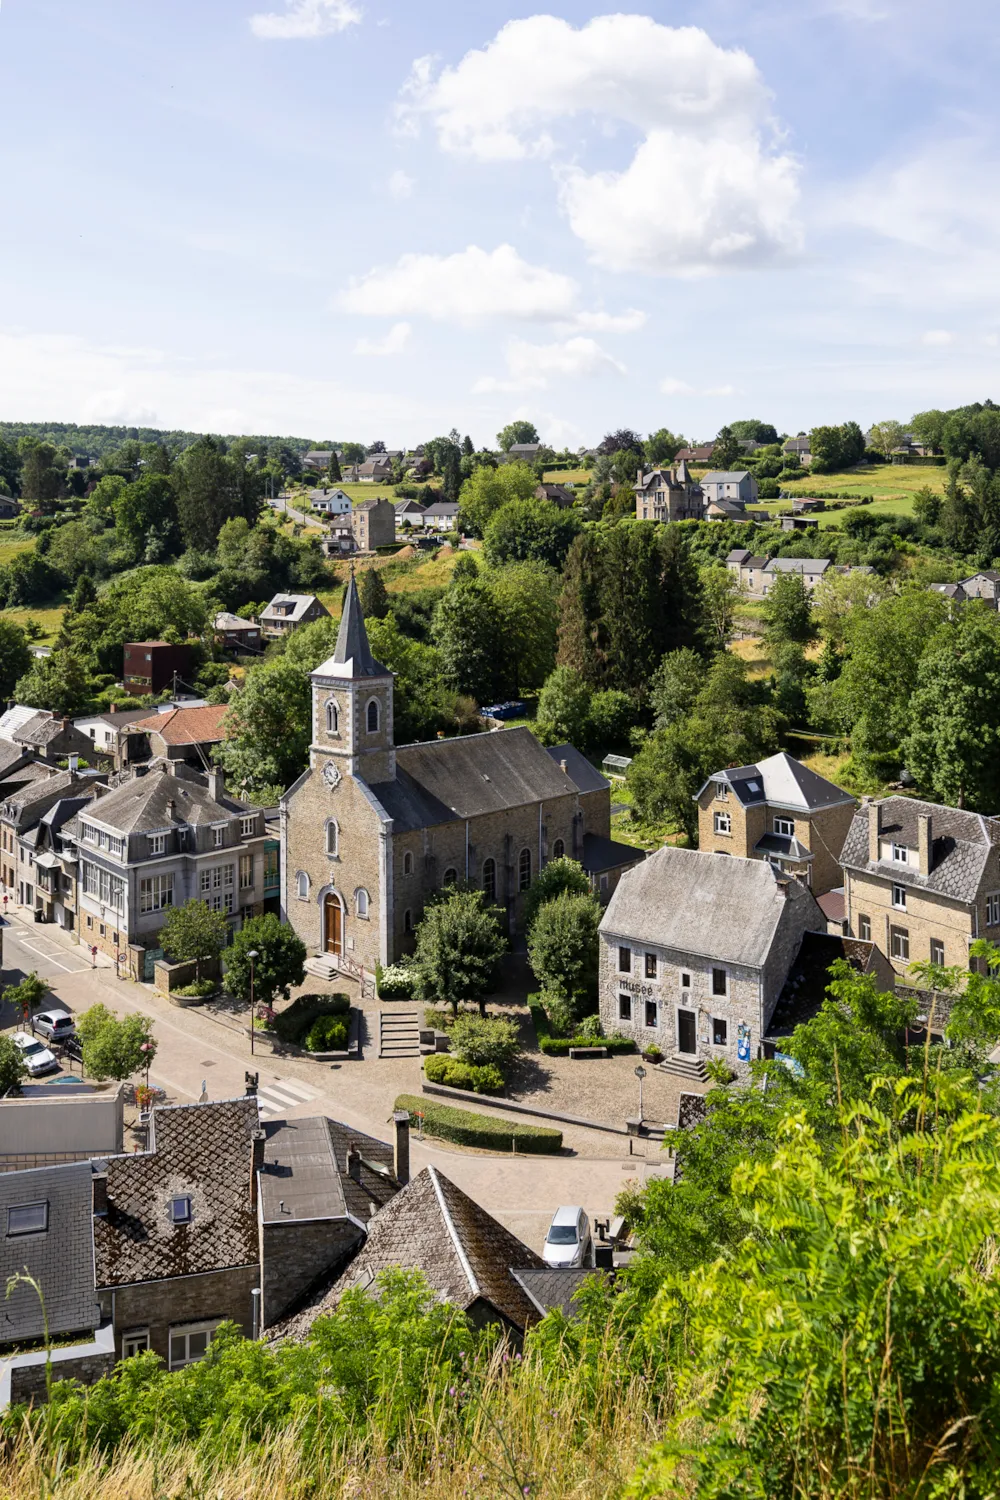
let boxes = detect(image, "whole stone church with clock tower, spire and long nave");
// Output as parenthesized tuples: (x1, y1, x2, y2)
(280, 578, 643, 974)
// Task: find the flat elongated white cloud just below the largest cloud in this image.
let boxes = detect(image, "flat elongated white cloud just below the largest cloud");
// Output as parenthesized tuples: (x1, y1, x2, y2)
(339, 245, 577, 326)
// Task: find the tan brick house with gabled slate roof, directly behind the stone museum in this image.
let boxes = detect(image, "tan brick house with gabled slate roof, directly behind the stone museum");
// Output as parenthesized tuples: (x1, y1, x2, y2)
(694, 750, 858, 896)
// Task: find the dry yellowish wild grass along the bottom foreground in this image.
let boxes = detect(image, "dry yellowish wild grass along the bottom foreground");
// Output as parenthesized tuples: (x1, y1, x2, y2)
(0, 1344, 666, 1500)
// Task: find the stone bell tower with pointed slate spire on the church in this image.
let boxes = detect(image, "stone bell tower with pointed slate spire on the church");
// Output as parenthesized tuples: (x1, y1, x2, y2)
(309, 573, 396, 789)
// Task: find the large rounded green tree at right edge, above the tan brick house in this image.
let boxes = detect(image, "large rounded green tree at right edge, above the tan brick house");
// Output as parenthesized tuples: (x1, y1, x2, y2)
(903, 606, 1000, 813)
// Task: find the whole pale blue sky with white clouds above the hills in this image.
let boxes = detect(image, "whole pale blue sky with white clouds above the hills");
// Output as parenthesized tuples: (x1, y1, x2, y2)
(0, 0, 1000, 447)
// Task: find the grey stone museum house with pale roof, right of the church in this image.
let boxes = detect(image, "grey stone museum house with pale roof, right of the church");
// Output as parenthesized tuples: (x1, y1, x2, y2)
(600, 846, 826, 1076)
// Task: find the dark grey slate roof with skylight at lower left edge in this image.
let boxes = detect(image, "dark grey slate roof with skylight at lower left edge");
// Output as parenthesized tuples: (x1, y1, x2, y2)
(0, 1161, 100, 1344)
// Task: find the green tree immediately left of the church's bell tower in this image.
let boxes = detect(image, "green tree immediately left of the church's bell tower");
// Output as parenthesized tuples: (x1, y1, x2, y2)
(214, 657, 305, 800)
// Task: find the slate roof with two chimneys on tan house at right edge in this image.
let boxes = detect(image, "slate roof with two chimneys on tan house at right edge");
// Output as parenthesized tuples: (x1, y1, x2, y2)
(841, 797, 1000, 905)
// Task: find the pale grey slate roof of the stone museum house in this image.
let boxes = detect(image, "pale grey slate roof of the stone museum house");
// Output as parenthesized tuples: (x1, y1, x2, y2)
(601, 846, 825, 969)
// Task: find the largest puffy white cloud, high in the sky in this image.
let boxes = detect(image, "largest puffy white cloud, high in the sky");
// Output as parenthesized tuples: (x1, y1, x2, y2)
(397, 15, 801, 275)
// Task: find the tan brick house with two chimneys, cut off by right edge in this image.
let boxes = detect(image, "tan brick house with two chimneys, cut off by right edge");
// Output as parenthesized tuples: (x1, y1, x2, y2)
(841, 797, 1000, 975)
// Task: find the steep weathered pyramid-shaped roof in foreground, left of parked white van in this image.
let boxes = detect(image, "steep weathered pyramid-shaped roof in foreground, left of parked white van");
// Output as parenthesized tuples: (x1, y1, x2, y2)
(271, 1167, 543, 1338)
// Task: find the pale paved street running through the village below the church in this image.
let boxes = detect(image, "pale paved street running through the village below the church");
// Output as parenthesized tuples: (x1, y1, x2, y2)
(0, 911, 664, 1250)
